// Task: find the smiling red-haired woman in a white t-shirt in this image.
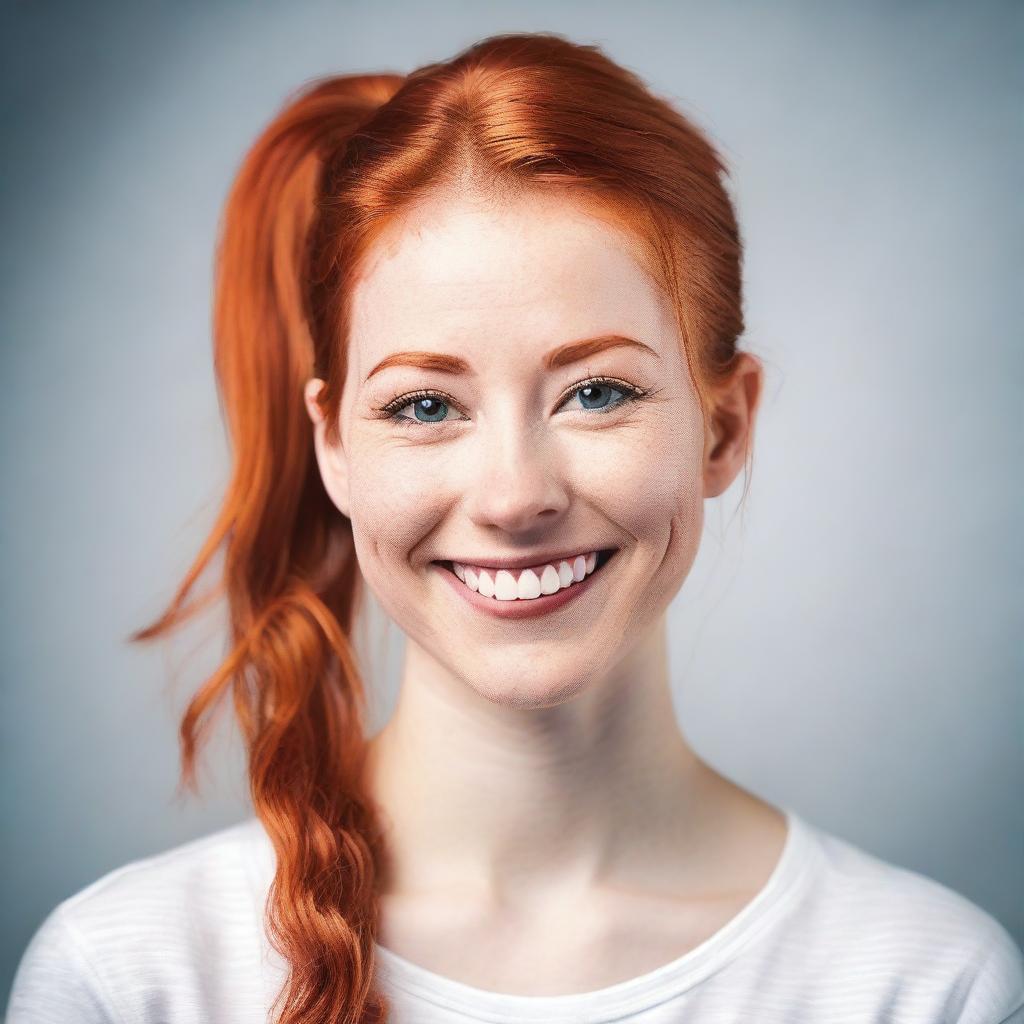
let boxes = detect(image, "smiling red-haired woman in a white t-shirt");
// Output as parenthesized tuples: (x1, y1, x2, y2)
(9, 34, 1024, 1024)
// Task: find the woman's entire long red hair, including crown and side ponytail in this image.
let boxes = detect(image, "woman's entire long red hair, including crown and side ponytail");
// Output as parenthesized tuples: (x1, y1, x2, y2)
(131, 33, 743, 1024)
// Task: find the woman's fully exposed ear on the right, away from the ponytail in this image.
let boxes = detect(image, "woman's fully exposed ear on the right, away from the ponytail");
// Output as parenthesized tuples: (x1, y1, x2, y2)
(703, 352, 764, 498)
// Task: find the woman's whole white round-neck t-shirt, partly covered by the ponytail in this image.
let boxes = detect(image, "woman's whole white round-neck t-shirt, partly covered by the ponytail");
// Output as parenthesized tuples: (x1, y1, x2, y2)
(7, 809, 1024, 1024)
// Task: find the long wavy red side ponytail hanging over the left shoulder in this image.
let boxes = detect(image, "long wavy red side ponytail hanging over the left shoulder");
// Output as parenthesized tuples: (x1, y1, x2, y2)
(131, 76, 401, 1024)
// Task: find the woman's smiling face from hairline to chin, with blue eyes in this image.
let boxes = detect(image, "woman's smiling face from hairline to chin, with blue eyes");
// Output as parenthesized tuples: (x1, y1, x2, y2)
(306, 188, 705, 707)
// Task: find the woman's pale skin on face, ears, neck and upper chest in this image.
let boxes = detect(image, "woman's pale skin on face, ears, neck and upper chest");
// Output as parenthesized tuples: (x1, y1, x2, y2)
(305, 180, 785, 995)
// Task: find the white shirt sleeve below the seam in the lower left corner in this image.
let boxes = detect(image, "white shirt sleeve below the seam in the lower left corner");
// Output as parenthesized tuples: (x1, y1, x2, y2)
(4, 905, 122, 1024)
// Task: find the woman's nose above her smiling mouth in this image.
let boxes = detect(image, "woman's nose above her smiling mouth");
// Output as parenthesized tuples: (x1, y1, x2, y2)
(467, 418, 569, 535)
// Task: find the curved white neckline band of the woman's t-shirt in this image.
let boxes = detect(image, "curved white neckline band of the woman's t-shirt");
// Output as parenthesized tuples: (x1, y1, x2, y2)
(375, 806, 814, 1024)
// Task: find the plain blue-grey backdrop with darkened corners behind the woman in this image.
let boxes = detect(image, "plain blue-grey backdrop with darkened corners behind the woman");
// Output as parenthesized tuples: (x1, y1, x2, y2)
(0, 0, 1024, 993)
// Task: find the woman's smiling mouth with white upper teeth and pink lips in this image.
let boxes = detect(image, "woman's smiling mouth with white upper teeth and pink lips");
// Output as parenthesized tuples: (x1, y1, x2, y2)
(434, 548, 616, 618)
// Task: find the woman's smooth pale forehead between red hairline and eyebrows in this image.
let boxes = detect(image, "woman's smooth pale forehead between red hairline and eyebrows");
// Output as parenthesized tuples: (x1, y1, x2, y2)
(350, 188, 669, 379)
